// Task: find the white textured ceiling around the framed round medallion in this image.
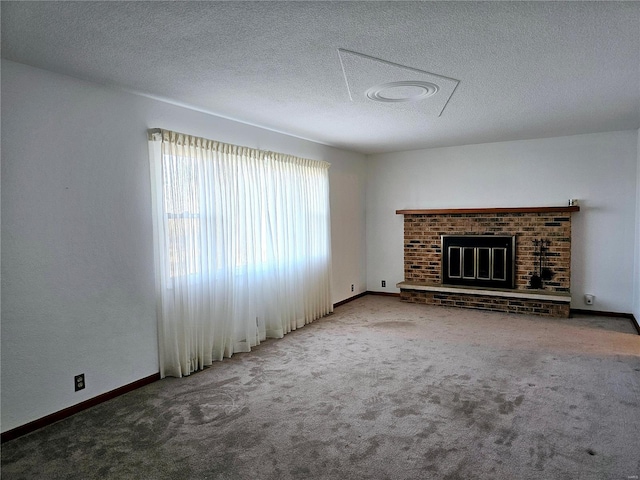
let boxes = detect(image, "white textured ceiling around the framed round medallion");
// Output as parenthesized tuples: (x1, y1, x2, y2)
(1, 1, 640, 153)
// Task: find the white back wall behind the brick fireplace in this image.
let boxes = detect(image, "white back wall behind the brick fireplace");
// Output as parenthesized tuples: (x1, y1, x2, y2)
(367, 131, 638, 313)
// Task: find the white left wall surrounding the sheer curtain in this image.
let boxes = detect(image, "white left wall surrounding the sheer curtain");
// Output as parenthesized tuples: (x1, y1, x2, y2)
(2, 60, 366, 431)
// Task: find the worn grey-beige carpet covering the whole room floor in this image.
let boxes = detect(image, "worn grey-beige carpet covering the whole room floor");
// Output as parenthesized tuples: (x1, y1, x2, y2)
(2, 296, 640, 480)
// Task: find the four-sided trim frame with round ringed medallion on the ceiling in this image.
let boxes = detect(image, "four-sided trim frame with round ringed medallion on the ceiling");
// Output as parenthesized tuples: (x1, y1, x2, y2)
(338, 48, 460, 117)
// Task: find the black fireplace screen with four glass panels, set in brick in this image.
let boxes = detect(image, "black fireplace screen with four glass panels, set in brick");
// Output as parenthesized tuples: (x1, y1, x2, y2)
(442, 235, 516, 288)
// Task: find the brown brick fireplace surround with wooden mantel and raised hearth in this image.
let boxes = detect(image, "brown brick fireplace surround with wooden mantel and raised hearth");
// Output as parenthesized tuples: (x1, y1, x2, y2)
(396, 206, 579, 317)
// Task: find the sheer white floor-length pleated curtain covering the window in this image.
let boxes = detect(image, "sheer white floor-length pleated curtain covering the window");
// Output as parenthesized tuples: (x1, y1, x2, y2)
(149, 130, 333, 377)
